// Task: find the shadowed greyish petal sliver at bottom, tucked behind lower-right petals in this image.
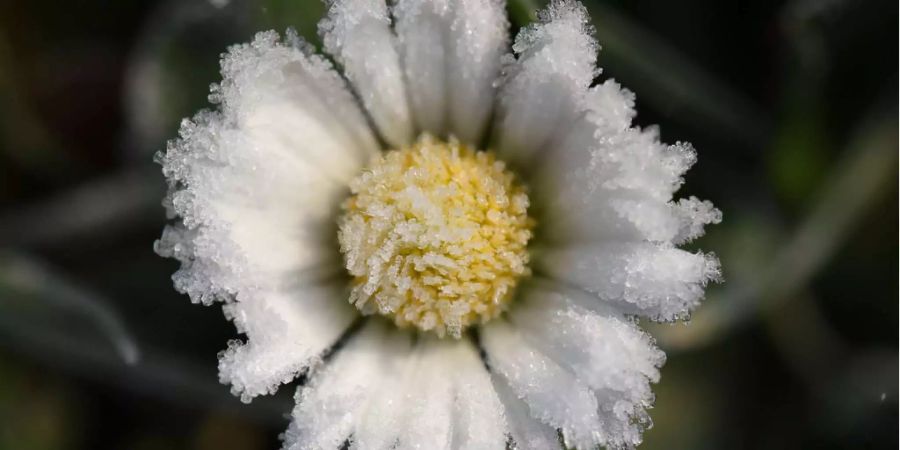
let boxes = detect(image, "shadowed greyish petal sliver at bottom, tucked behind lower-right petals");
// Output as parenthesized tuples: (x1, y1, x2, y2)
(491, 376, 561, 450)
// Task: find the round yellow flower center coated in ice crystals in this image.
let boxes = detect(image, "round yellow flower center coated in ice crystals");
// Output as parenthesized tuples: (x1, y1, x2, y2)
(338, 135, 534, 338)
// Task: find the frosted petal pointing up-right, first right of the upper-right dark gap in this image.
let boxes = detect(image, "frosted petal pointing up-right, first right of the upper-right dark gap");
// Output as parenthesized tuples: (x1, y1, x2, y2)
(495, 1, 598, 167)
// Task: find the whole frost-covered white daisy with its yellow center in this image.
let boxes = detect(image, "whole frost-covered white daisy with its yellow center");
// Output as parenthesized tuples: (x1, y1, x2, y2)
(157, 0, 720, 449)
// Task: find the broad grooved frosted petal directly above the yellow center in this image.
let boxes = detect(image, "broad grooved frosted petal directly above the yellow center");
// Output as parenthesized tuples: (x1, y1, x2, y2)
(394, 0, 508, 143)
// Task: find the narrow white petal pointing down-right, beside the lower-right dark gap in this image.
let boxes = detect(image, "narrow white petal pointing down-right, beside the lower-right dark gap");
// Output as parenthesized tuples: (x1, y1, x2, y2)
(482, 320, 600, 449)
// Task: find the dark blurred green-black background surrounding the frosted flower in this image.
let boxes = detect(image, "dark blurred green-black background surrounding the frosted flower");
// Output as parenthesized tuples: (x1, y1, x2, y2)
(0, 0, 898, 450)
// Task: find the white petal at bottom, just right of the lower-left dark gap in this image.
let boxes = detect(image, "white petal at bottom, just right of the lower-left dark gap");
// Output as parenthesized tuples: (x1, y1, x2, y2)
(284, 320, 410, 450)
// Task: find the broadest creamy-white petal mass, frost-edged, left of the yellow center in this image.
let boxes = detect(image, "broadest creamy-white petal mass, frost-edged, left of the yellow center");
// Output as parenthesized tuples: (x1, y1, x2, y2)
(157, 33, 377, 303)
